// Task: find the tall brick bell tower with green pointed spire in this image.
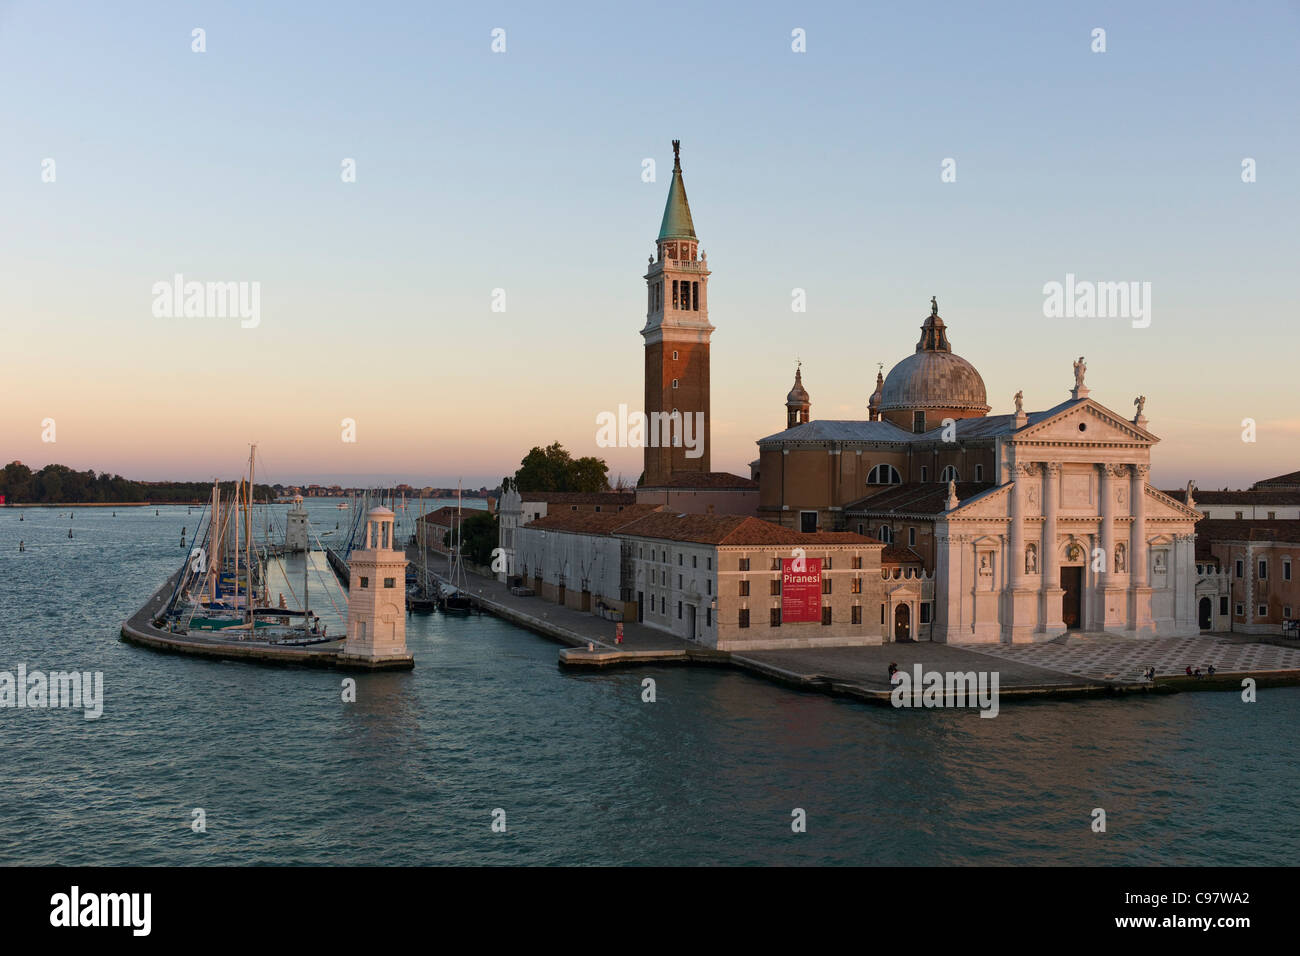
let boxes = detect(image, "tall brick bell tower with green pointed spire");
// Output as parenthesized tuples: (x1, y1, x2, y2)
(641, 139, 714, 486)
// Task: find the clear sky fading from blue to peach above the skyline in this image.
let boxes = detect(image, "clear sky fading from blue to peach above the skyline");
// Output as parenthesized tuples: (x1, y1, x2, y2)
(0, 0, 1300, 488)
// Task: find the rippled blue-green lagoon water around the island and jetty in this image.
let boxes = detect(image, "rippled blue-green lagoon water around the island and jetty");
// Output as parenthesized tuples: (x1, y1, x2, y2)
(0, 501, 1300, 865)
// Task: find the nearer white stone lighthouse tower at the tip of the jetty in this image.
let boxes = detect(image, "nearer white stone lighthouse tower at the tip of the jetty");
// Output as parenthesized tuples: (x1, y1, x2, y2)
(337, 507, 415, 667)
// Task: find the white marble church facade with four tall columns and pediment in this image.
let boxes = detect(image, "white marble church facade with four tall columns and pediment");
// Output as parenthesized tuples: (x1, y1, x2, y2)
(933, 399, 1200, 644)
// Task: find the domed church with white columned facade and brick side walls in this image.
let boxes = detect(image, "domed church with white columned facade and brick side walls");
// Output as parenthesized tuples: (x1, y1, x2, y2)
(751, 299, 1201, 644)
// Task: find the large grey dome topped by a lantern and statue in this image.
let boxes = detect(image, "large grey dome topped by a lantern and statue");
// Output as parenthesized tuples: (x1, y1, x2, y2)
(880, 299, 989, 415)
